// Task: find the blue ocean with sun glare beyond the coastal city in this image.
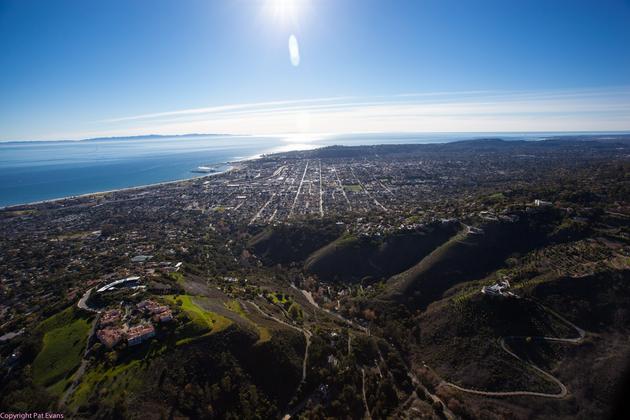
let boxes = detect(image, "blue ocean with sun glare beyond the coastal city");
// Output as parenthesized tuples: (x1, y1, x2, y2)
(0, 133, 624, 207)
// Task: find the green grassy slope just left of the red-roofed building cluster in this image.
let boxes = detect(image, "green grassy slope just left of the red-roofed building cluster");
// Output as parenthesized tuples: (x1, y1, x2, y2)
(33, 307, 91, 388)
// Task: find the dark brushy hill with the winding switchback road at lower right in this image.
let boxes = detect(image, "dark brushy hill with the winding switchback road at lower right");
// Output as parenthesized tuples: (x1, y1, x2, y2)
(412, 270, 630, 418)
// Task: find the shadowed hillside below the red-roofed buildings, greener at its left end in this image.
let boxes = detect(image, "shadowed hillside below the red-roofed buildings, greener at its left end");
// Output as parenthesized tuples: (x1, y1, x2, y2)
(68, 324, 303, 418)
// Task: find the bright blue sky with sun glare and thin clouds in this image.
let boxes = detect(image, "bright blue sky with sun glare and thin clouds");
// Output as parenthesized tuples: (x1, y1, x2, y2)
(0, 0, 630, 140)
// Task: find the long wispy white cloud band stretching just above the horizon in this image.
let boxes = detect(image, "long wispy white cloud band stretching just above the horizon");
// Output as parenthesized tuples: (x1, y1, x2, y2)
(45, 87, 630, 138)
